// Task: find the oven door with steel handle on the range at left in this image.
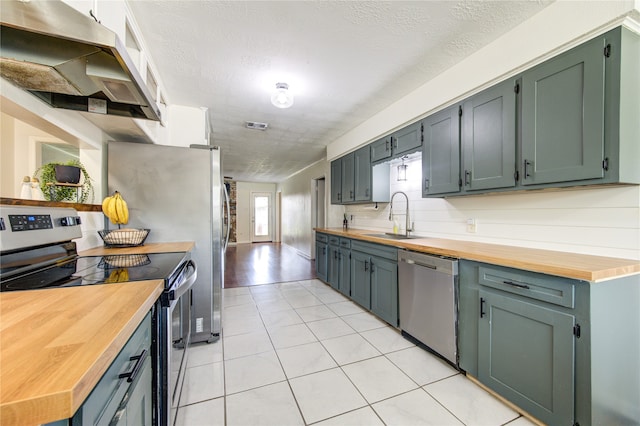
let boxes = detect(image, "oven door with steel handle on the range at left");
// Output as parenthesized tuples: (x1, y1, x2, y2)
(159, 260, 197, 426)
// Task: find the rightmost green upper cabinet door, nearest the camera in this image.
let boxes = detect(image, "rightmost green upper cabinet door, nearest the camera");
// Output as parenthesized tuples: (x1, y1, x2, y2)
(520, 37, 605, 185)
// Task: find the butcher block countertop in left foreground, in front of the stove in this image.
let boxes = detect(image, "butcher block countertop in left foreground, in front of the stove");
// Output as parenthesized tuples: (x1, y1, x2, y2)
(0, 280, 163, 425)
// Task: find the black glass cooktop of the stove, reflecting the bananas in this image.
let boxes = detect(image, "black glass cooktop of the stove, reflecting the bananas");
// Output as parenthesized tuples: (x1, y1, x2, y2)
(1, 252, 189, 291)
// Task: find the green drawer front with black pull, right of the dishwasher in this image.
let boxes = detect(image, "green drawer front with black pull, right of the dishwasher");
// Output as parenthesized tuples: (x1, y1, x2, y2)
(478, 266, 575, 308)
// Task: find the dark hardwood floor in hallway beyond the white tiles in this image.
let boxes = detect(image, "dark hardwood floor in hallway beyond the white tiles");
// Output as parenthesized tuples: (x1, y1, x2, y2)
(224, 243, 316, 288)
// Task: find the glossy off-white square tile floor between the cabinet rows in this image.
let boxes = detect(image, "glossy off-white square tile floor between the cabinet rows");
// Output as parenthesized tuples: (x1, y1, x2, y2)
(176, 280, 533, 426)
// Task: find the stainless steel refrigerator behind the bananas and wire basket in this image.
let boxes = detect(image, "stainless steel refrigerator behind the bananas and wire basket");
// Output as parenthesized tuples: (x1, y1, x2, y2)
(107, 142, 229, 342)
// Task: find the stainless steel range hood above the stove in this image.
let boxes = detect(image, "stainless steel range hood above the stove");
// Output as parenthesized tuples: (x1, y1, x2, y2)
(0, 0, 160, 121)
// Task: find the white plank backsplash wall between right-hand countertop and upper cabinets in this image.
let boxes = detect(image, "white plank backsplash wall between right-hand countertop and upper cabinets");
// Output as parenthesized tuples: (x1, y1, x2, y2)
(346, 158, 640, 259)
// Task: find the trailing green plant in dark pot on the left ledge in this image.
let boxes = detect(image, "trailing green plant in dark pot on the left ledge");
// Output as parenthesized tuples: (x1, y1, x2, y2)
(33, 160, 94, 203)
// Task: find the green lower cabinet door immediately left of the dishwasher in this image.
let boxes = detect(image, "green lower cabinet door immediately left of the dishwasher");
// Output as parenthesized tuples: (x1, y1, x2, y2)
(371, 257, 398, 327)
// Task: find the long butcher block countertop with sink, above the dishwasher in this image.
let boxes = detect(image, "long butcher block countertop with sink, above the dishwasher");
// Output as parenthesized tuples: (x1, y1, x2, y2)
(316, 228, 640, 282)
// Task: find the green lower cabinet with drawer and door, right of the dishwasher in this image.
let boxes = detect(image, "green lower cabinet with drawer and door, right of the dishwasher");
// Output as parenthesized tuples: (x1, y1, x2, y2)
(458, 260, 592, 425)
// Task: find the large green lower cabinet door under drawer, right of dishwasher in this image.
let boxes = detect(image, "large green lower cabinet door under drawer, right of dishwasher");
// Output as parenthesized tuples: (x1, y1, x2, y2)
(478, 289, 575, 425)
